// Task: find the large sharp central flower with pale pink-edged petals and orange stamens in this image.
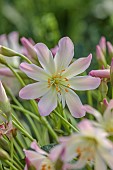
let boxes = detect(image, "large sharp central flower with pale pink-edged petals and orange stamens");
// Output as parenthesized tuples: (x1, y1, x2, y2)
(19, 37, 100, 118)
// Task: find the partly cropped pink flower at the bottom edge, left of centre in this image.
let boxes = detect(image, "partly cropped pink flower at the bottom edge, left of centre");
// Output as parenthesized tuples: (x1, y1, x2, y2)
(24, 141, 55, 170)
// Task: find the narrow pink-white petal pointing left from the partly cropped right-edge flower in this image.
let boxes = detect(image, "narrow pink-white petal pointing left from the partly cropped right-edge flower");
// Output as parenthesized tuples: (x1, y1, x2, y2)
(84, 105, 103, 122)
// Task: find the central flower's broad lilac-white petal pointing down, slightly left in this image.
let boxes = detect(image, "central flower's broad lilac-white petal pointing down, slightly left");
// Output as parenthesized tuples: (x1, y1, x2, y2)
(38, 88, 57, 116)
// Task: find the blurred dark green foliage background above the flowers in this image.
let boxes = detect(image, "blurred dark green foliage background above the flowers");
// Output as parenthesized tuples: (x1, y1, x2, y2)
(0, 0, 113, 57)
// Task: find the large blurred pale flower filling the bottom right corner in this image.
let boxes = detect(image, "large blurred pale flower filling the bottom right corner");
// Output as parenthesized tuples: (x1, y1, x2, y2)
(61, 119, 113, 170)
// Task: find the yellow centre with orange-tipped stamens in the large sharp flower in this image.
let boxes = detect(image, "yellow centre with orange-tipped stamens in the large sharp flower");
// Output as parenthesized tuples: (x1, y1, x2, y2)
(48, 70, 70, 94)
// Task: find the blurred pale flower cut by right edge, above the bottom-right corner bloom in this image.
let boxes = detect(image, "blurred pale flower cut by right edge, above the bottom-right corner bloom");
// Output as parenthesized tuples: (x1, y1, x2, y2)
(84, 100, 113, 135)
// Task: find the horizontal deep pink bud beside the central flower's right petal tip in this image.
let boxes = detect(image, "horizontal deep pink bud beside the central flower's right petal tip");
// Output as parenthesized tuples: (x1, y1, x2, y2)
(89, 69, 110, 78)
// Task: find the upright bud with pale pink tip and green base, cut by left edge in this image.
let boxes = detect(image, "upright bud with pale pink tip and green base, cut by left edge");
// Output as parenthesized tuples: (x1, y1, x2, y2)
(0, 81, 11, 114)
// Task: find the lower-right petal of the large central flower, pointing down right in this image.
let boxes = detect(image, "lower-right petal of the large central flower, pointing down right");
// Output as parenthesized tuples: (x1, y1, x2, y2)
(65, 89, 85, 118)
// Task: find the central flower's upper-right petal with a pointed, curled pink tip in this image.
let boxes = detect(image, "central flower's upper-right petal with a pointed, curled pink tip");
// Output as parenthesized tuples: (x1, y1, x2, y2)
(62, 54, 92, 78)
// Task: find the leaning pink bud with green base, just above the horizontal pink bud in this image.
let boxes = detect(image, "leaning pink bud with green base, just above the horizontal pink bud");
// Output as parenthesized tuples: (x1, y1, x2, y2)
(96, 45, 106, 66)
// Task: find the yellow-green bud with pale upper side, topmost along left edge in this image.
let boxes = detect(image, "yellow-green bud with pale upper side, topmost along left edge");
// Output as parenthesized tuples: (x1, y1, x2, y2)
(0, 46, 17, 57)
